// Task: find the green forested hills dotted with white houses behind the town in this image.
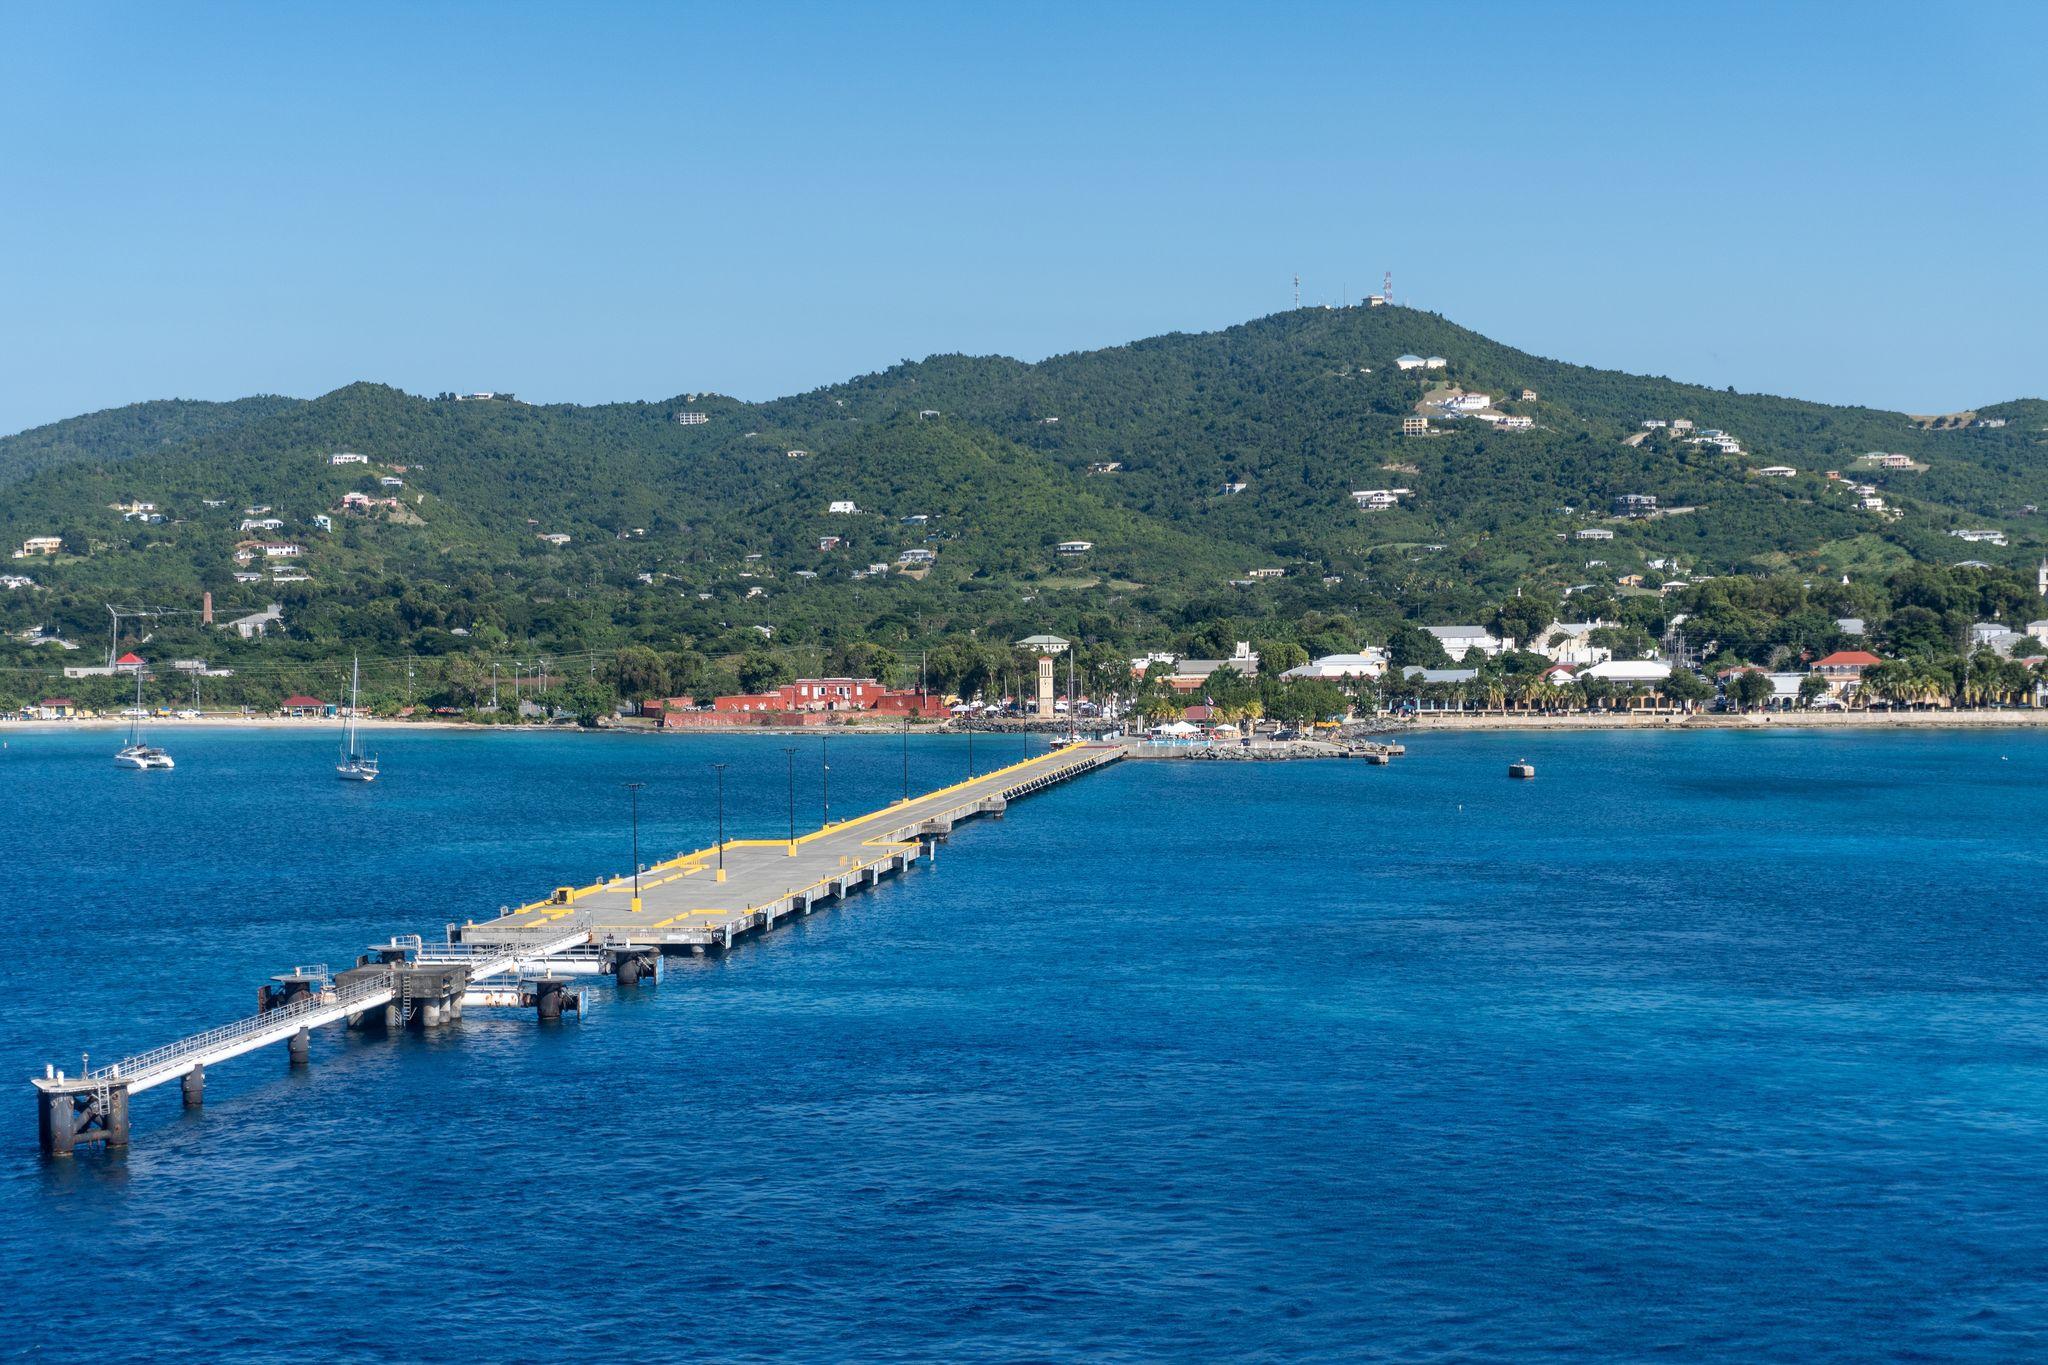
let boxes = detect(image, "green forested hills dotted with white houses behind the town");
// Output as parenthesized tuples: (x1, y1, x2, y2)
(0, 307, 2048, 716)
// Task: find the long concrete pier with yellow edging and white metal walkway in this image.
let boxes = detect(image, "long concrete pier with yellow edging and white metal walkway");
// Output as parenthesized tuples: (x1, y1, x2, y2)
(33, 743, 1124, 1156)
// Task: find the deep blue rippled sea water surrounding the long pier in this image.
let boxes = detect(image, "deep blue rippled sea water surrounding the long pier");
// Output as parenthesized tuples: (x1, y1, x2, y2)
(0, 731, 2048, 1361)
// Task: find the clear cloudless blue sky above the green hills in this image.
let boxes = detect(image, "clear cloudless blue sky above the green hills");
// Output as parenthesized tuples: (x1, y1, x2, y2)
(0, 4, 2048, 432)
